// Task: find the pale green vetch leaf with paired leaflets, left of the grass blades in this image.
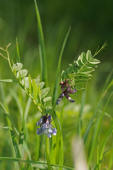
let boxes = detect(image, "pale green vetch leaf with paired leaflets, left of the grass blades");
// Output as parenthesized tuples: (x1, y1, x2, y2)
(12, 63, 51, 113)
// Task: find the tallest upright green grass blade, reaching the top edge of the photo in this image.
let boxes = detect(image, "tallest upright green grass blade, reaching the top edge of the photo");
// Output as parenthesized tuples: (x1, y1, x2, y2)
(34, 0, 47, 82)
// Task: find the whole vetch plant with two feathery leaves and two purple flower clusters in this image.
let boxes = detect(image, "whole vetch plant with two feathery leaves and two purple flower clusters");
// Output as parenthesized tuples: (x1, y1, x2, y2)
(1, 41, 100, 137)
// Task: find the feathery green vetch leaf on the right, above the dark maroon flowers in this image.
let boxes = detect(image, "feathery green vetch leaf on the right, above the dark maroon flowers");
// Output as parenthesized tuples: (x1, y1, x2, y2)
(61, 50, 100, 90)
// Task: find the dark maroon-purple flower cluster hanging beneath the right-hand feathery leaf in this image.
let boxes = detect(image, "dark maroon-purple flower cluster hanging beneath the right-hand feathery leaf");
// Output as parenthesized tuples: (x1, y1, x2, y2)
(56, 80, 76, 104)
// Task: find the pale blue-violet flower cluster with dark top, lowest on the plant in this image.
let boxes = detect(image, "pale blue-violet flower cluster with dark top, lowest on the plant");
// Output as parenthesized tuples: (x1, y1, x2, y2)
(37, 114, 57, 138)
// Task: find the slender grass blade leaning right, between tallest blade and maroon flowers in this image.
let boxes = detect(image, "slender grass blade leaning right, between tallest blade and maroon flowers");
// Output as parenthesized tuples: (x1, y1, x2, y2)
(52, 27, 71, 107)
